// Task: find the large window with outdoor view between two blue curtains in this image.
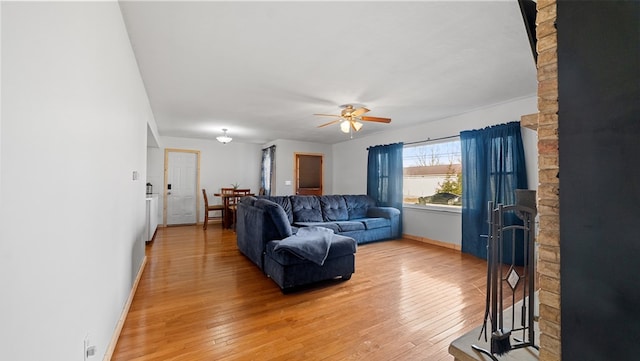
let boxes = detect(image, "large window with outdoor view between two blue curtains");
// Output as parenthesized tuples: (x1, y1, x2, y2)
(402, 139, 462, 207)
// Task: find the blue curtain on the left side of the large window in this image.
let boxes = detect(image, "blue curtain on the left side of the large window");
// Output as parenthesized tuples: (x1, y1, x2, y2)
(367, 143, 404, 234)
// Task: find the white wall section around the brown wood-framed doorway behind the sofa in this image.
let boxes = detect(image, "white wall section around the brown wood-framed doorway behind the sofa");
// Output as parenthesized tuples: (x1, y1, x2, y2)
(262, 139, 334, 196)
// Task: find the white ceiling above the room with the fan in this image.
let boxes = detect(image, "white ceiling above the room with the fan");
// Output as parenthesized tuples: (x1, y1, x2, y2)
(120, 0, 537, 143)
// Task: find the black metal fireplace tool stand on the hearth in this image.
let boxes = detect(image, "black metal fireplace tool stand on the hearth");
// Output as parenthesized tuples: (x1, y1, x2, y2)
(471, 198, 538, 361)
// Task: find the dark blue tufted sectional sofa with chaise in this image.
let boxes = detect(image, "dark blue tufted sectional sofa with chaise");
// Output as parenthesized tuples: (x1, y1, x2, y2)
(236, 195, 400, 292)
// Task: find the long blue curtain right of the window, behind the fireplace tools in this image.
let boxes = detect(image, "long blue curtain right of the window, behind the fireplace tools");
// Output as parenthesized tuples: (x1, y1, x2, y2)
(460, 122, 527, 264)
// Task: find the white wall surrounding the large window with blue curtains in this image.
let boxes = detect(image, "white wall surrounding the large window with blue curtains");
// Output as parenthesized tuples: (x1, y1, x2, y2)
(333, 96, 538, 245)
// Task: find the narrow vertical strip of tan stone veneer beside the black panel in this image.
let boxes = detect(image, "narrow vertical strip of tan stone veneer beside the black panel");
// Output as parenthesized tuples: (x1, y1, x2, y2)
(536, 0, 561, 361)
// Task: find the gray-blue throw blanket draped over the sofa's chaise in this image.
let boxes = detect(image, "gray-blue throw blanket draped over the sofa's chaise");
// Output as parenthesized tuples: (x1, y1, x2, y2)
(274, 226, 333, 266)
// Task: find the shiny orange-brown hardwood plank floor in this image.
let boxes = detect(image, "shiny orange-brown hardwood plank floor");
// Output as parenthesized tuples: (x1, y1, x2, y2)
(112, 224, 486, 361)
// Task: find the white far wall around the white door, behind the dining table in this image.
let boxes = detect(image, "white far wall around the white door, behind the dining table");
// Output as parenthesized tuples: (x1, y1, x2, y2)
(147, 136, 262, 224)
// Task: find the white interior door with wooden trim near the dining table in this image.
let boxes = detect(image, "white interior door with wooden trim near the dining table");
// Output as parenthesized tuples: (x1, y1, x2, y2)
(166, 152, 197, 225)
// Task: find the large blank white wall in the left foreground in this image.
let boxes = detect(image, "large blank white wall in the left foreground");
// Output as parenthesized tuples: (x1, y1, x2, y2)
(0, 1, 152, 361)
